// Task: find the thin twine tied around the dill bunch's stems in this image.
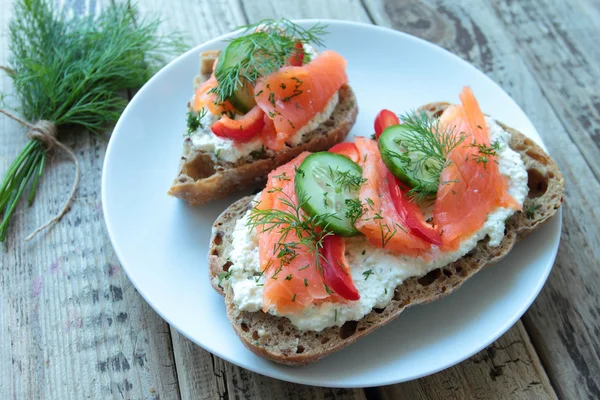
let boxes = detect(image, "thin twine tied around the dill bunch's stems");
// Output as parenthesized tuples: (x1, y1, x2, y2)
(0, 108, 80, 241)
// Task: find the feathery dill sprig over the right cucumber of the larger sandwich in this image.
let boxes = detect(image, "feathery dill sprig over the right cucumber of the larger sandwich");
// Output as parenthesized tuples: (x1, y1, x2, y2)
(386, 111, 465, 202)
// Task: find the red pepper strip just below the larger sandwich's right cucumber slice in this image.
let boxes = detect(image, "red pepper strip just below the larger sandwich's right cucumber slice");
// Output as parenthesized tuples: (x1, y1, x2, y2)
(387, 171, 442, 246)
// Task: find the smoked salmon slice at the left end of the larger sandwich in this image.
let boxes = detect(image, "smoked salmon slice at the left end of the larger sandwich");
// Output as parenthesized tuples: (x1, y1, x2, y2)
(256, 152, 344, 315)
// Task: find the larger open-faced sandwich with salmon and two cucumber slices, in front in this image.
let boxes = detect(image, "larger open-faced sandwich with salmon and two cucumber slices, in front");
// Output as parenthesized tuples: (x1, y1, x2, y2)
(209, 88, 563, 365)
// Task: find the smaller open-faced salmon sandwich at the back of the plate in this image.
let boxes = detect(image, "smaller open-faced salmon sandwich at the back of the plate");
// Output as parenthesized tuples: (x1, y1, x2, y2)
(169, 19, 358, 205)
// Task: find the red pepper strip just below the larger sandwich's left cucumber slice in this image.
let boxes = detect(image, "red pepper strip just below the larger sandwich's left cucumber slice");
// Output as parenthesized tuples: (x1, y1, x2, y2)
(322, 235, 360, 300)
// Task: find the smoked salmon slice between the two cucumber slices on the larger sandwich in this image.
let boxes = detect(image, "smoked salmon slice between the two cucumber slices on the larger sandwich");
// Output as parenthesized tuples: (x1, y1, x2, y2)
(354, 137, 431, 256)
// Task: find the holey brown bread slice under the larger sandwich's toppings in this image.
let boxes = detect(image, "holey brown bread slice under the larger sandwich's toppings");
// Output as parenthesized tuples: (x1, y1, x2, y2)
(209, 103, 564, 365)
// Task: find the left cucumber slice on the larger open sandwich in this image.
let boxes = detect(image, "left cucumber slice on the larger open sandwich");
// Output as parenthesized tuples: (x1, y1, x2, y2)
(295, 151, 363, 236)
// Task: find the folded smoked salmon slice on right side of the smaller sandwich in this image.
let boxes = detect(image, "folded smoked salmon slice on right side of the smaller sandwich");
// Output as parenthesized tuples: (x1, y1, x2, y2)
(254, 50, 348, 150)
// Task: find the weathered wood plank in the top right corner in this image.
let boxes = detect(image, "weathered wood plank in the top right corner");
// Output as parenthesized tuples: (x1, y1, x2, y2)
(494, 0, 600, 179)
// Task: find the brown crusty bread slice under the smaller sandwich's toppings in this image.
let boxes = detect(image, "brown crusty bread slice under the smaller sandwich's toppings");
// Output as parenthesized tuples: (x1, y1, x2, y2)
(169, 51, 358, 205)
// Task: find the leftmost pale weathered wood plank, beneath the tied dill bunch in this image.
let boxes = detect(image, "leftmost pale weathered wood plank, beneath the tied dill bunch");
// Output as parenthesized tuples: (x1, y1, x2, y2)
(0, 1, 179, 399)
